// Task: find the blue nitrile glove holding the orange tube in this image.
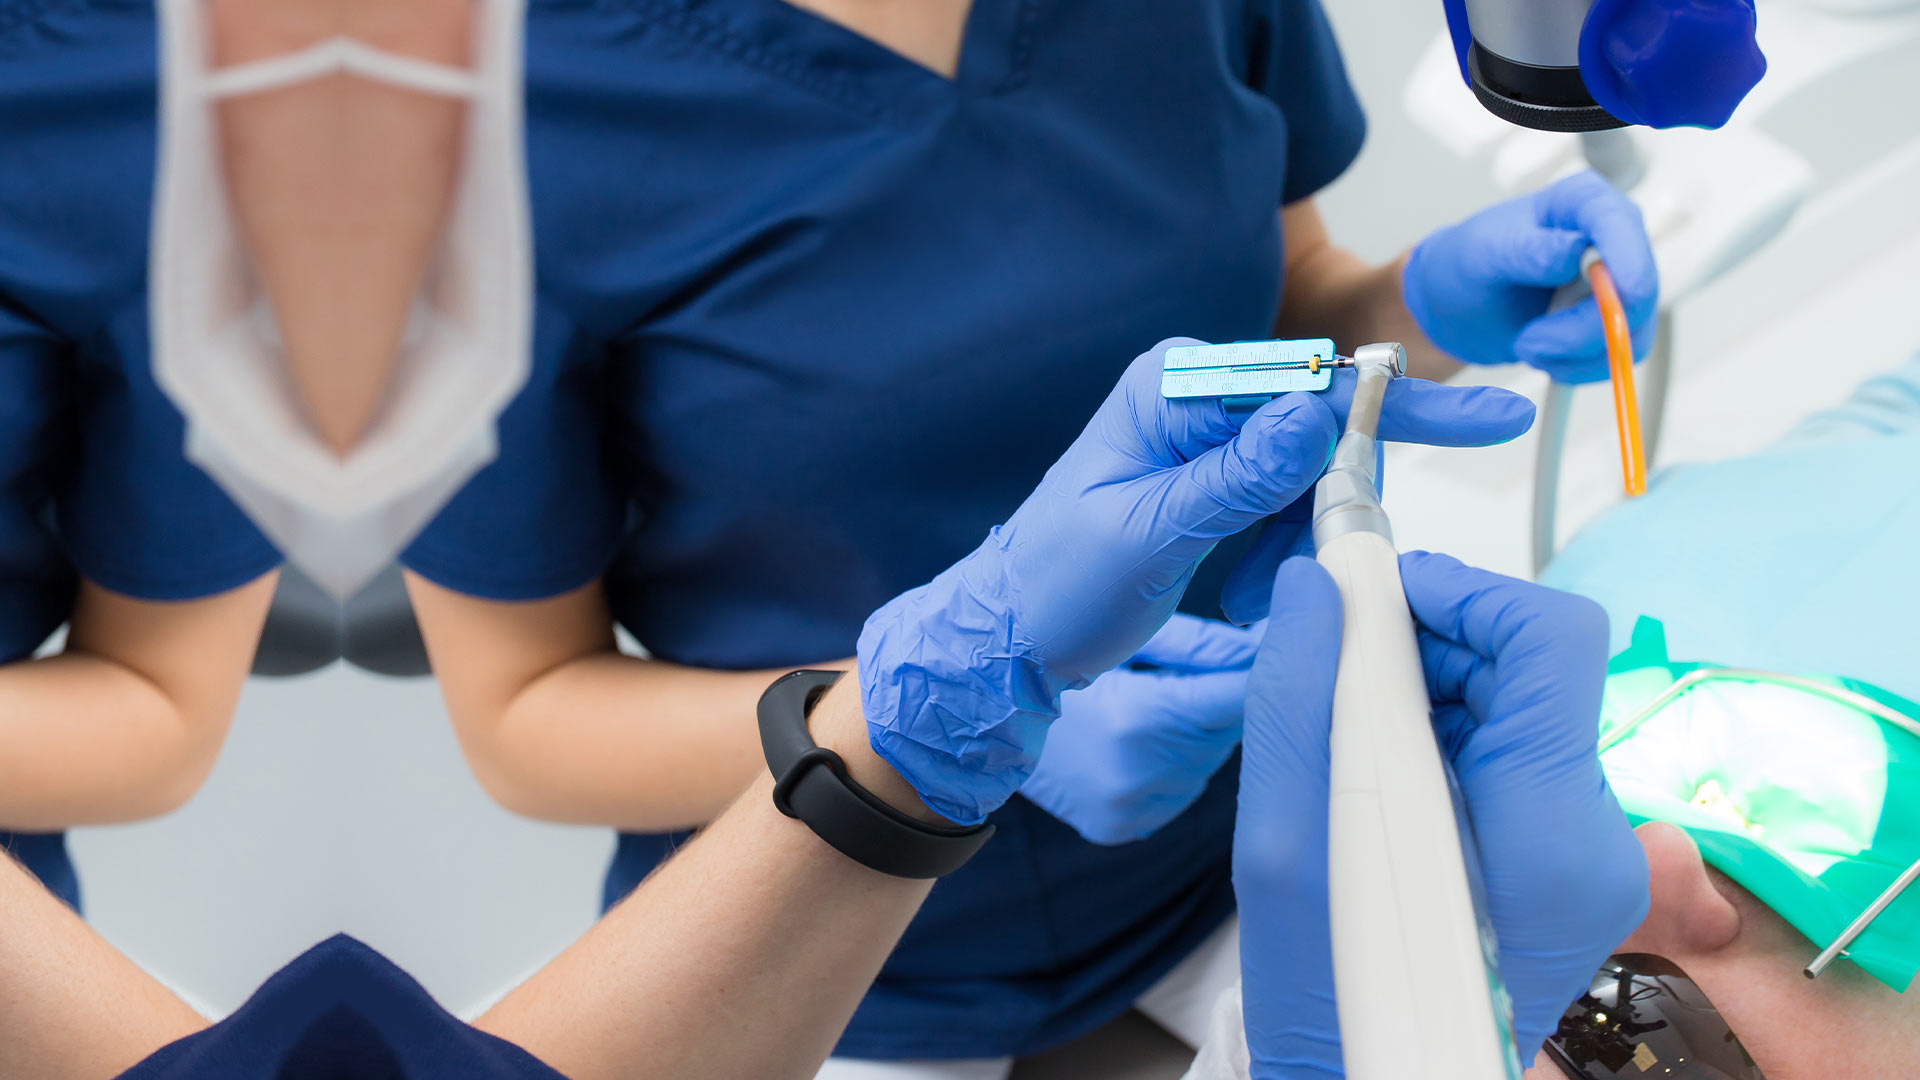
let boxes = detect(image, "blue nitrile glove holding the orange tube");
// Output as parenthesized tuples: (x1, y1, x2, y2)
(1400, 169, 1661, 382)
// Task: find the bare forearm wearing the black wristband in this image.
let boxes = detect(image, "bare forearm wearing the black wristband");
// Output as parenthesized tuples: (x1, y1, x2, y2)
(476, 678, 931, 1080)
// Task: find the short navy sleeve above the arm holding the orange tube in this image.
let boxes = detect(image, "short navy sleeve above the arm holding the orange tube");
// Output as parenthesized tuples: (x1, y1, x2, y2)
(1246, 0, 1367, 206)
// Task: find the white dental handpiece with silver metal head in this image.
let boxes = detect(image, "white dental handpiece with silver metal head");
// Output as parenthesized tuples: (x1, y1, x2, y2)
(1313, 344, 1523, 1080)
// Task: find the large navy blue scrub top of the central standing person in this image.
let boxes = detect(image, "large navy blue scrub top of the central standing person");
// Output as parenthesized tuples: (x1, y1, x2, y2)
(405, 0, 1365, 1059)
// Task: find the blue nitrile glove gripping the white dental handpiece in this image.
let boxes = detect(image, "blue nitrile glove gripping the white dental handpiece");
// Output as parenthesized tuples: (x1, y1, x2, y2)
(1233, 552, 1647, 1080)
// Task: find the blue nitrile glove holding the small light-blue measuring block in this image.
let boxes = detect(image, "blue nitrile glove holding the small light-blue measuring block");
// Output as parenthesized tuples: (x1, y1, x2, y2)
(858, 338, 1534, 822)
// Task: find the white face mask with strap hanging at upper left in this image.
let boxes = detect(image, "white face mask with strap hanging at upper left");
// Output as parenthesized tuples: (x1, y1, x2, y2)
(150, 0, 534, 600)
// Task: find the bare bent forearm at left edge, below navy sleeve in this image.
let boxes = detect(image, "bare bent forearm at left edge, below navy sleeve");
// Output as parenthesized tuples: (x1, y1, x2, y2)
(0, 651, 227, 832)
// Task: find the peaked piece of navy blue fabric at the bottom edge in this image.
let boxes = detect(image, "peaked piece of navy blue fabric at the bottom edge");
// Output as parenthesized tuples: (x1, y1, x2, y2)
(119, 934, 564, 1080)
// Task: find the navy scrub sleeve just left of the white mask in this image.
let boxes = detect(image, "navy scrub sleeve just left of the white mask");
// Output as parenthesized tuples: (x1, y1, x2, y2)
(54, 309, 280, 601)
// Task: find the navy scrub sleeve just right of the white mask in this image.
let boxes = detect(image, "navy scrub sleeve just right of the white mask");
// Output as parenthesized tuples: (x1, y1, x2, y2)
(399, 321, 626, 601)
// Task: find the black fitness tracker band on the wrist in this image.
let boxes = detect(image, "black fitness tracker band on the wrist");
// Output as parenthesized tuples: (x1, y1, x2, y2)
(760, 671, 993, 878)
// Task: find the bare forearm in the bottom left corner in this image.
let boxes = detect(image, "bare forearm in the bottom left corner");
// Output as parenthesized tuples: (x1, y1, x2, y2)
(0, 855, 207, 1080)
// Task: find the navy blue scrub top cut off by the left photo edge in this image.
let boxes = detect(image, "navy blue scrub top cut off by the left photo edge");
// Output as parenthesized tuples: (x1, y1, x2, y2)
(0, 0, 280, 907)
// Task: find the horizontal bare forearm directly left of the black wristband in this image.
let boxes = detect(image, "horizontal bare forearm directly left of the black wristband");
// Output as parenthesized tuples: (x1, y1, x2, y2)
(474, 651, 839, 832)
